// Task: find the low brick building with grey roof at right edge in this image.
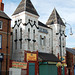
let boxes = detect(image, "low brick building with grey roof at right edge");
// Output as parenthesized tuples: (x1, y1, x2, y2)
(66, 48, 75, 75)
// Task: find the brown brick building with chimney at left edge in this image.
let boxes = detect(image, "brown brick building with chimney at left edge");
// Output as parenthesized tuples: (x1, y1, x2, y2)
(0, 0, 11, 75)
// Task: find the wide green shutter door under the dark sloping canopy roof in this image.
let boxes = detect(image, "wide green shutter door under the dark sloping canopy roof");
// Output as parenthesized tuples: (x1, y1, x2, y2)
(39, 64, 57, 75)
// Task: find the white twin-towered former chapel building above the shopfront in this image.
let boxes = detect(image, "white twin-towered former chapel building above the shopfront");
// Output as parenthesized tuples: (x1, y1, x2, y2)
(11, 0, 66, 61)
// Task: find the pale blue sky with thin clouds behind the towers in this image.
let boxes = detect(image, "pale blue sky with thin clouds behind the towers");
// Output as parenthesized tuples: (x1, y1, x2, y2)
(3, 0, 75, 47)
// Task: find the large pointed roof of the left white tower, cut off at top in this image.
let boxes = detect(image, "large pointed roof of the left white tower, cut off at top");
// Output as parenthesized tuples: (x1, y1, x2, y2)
(13, 0, 39, 16)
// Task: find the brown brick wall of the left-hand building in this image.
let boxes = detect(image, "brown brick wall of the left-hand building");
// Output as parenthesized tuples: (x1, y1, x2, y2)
(0, 18, 11, 71)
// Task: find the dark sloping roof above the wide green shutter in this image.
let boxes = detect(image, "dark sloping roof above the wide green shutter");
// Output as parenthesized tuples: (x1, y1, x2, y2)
(38, 52, 60, 62)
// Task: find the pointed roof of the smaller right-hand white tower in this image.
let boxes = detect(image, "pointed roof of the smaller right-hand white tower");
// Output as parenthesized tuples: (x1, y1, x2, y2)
(46, 8, 65, 26)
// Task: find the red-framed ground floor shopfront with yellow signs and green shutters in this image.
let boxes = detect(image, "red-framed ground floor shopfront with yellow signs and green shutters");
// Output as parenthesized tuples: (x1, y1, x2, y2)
(10, 51, 60, 75)
